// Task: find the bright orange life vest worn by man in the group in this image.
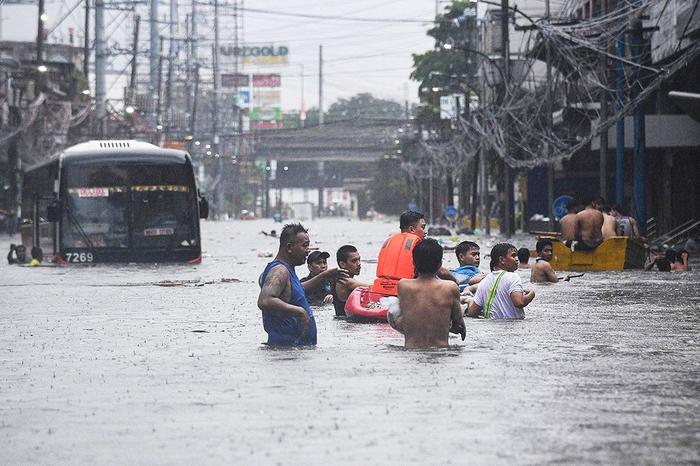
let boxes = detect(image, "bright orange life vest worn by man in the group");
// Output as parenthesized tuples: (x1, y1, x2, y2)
(371, 233, 421, 296)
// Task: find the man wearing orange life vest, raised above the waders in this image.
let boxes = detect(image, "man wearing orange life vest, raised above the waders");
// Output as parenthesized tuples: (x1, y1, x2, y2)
(372, 210, 457, 296)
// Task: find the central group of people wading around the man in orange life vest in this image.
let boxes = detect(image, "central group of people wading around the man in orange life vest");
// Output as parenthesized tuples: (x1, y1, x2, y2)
(258, 211, 576, 348)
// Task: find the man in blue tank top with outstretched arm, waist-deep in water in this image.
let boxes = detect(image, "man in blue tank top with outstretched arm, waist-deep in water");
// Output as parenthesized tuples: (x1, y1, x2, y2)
(258, 223, 338, 346)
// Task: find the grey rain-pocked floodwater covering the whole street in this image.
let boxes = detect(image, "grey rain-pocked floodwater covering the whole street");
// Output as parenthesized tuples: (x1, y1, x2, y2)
(0, 219, 700, 465)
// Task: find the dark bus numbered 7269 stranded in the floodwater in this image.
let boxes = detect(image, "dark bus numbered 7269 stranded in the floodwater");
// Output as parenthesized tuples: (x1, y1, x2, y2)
(22, 141, 209, 263)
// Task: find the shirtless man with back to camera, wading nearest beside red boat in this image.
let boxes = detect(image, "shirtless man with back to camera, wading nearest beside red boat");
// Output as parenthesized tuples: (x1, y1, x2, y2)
(395, 239, 466, 348)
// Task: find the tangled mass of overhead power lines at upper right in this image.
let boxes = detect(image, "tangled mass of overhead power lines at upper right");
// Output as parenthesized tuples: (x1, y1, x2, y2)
(418, 0, 700, 168)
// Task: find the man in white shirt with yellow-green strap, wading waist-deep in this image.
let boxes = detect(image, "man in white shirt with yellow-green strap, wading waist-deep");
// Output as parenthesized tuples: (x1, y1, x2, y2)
(467, 243, 535, 319)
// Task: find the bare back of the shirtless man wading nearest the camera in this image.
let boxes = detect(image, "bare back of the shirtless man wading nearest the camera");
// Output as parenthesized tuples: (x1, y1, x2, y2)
(398, 276, 464, 348)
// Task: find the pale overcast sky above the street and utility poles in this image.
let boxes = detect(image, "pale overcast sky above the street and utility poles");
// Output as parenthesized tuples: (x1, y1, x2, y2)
(2, 0, 556, 109)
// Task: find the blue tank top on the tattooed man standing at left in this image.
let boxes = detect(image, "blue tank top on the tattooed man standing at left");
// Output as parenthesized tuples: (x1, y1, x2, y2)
(258, 260, 316, 346)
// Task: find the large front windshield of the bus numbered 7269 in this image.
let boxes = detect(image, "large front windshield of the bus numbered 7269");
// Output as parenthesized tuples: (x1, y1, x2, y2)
(62, 163, 198, 249)
